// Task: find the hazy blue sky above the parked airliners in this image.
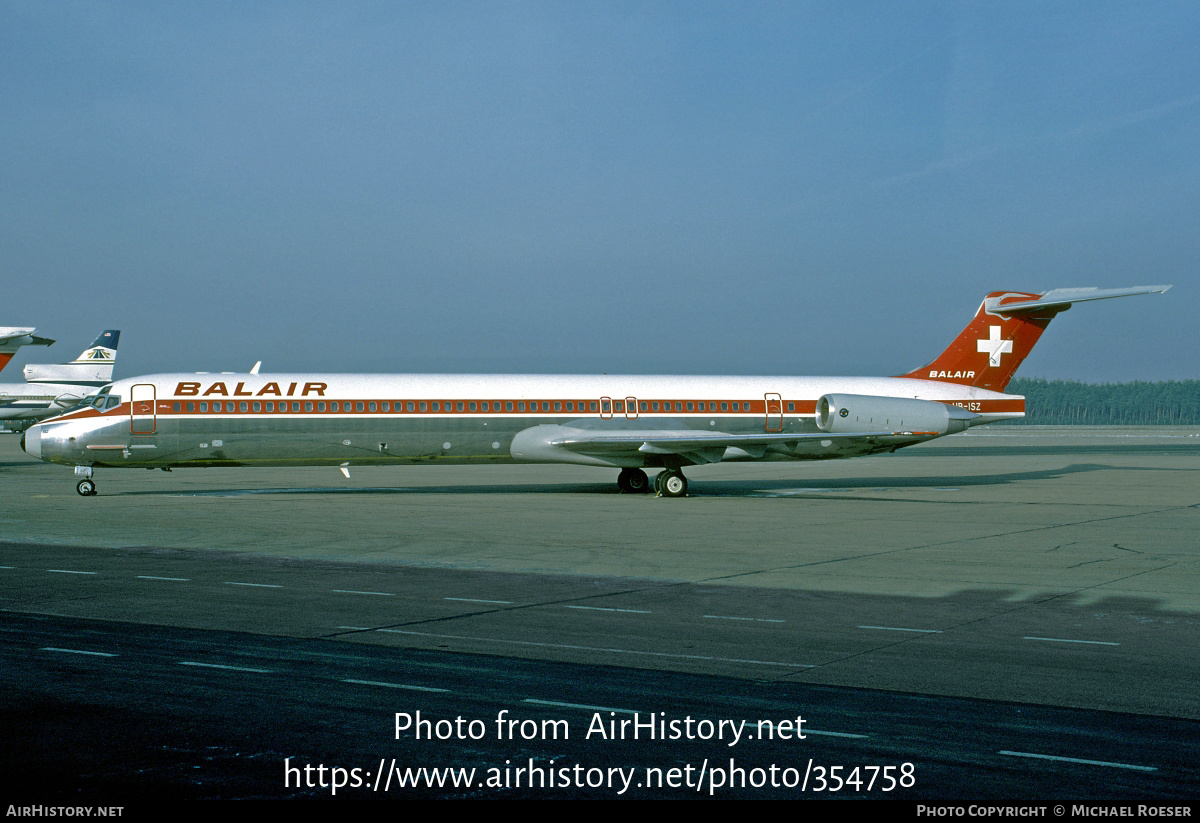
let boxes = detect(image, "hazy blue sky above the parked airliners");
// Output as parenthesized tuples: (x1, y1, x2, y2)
(0, 1, 1200, 382)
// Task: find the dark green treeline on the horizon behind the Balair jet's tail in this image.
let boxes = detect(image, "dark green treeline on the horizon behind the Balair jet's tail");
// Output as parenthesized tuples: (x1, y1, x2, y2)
(1004, 377, 1200, 426)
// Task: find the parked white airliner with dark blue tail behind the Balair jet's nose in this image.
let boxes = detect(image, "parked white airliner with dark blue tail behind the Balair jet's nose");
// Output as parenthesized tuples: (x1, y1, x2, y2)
(0, 329, 121, 431)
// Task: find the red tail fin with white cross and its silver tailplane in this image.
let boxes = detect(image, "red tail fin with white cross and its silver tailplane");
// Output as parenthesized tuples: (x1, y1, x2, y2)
(900, 286, 1171, 391)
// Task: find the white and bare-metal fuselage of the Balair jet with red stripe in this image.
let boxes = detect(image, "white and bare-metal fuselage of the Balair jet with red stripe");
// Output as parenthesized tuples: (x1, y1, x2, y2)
(25, 373, 1024, 468)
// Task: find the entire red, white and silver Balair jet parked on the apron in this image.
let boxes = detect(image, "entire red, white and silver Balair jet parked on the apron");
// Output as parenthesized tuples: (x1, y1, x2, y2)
(22, 286, 1170, 497)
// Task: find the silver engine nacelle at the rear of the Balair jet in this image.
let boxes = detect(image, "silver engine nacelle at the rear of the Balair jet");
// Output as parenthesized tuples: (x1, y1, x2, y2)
(817, 395, 979, 434)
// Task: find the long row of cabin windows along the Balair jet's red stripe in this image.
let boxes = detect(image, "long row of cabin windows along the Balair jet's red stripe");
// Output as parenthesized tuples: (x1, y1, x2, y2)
(164, 400, 796, 413)
